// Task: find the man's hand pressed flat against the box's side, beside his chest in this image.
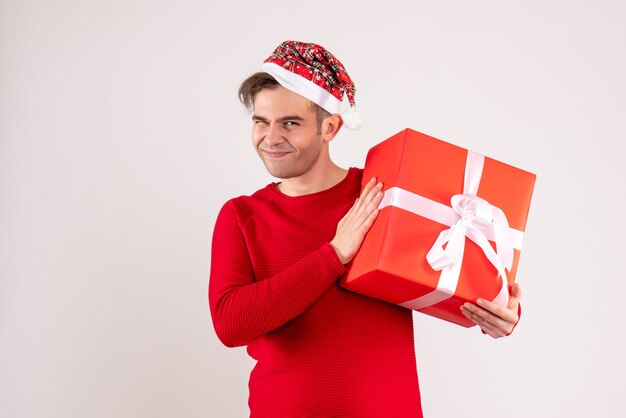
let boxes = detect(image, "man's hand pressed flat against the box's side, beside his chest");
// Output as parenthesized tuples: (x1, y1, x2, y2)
(330, 178, 383, 264)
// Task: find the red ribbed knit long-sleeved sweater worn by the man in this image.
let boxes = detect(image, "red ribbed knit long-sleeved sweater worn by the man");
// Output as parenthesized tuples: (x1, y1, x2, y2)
(209, 168, 422, 418)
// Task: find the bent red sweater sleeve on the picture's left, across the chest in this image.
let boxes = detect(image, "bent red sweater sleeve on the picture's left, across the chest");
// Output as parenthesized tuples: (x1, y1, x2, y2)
(209, 203, 346, 347)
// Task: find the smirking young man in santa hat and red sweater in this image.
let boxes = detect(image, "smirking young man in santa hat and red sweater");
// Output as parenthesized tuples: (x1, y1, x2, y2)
(209, 41, 520, 418)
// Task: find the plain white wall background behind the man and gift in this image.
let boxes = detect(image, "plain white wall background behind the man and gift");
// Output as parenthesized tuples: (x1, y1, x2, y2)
(0, 0, 626, 418)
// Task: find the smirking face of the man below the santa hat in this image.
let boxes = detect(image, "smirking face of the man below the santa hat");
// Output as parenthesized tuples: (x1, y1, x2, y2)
(252, 86, 323, 179)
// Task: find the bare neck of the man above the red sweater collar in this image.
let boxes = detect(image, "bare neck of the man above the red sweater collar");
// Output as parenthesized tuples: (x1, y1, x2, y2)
(277, 161, 348, 196)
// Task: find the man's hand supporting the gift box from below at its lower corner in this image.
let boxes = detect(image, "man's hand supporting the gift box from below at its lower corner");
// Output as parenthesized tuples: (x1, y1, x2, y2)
(461, 283, 522, 338)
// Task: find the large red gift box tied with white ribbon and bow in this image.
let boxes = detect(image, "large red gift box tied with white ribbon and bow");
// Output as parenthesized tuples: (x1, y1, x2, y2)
(341, 129, 536, 327)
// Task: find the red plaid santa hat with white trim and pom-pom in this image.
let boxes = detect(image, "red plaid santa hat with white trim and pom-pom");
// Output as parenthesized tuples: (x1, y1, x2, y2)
(262, 41, 363, 130)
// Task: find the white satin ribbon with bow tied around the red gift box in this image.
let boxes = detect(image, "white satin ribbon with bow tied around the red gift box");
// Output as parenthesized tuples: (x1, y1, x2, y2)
(379, 151, 524, 310)
